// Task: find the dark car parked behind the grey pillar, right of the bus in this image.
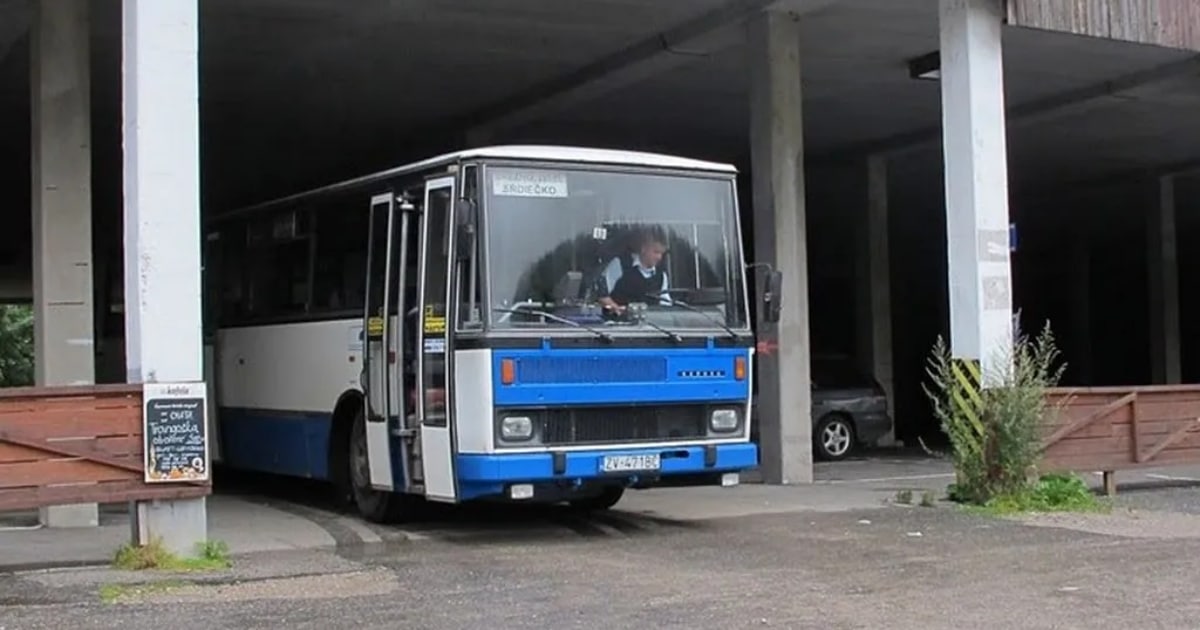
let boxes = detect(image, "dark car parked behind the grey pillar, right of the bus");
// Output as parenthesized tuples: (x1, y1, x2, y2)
(750, 356, 892, 461)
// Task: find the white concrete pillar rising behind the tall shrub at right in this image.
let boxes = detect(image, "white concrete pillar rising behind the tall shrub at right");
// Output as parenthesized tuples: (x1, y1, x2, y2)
(938, 0, 1013, 383)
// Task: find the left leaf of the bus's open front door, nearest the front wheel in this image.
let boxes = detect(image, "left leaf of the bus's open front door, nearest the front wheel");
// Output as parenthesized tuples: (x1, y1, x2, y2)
(362, 192, 402, 490)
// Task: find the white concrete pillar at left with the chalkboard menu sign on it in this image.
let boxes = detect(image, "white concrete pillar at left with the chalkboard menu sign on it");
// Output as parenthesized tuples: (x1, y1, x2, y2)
(121, 0, 208, 554)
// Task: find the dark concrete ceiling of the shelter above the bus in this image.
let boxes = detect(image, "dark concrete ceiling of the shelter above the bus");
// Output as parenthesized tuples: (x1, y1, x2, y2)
(0, 0, 1200, 210)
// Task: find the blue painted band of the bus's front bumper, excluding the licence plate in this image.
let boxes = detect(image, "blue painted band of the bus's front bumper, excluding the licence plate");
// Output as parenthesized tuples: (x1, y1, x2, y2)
(456, 443, 758, 500)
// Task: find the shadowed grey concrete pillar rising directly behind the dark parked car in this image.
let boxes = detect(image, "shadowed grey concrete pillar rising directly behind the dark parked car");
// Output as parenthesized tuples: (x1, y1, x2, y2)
(857, 155, 895, 446)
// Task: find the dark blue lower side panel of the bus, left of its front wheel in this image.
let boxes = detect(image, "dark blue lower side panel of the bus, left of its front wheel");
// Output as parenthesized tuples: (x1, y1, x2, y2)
(217, 407, 332, 480)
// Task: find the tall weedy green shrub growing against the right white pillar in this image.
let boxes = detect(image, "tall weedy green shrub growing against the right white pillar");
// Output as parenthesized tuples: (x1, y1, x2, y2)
(925, 325, 1063, 505)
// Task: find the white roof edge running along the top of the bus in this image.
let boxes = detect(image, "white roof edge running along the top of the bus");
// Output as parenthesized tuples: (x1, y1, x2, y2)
(212, 144, 738, 222)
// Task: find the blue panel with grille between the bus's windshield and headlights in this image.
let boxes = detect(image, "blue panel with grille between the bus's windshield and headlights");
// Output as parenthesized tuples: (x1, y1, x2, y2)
(492, 348, 750, 407)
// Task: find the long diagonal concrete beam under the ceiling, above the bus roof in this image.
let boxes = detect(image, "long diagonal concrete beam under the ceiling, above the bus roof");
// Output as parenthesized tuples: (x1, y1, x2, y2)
(464, 0, 836, 138)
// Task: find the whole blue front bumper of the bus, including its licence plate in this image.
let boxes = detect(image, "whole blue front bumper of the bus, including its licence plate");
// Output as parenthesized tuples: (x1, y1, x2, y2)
(456, 443, 758, 502)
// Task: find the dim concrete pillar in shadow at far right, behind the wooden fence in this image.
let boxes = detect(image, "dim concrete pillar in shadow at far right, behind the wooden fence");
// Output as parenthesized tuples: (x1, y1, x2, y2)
(1146, 175, 1182, 385)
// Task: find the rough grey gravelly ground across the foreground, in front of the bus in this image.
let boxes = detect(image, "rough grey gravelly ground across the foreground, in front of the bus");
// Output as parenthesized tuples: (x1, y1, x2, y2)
(0, 490, 1200, 630)
